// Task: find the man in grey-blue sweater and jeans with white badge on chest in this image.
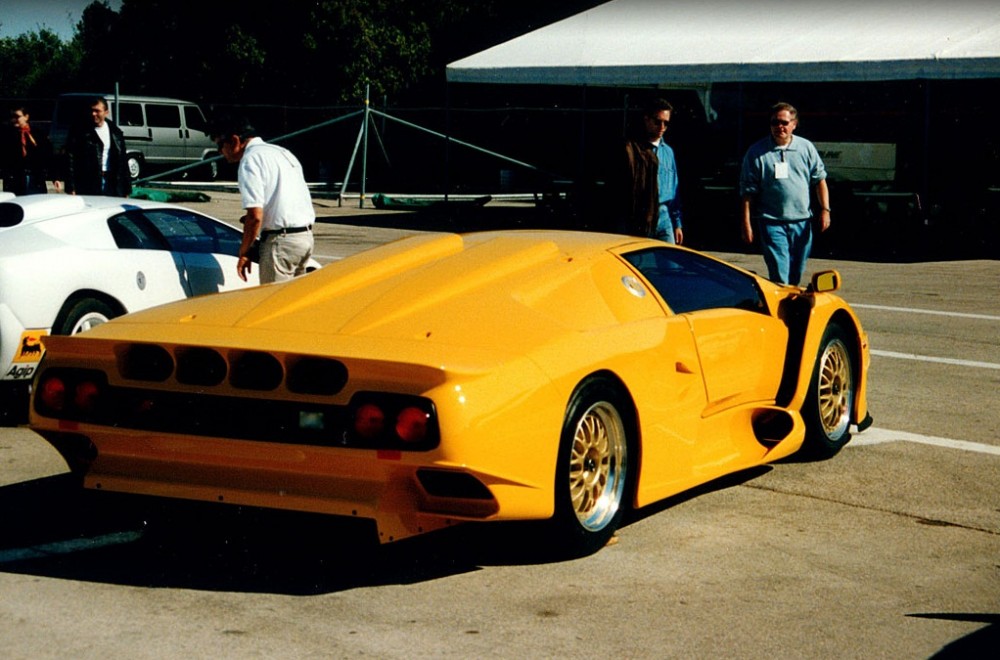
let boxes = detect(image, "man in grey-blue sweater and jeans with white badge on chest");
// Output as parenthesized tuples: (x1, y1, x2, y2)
(740, 103, 830, 285)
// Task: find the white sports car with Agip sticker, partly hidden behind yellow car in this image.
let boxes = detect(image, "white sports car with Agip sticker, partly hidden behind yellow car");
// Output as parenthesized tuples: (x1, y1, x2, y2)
(0, 193, 272, 423)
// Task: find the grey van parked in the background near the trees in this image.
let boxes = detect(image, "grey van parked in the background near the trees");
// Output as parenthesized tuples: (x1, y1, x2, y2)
(49, 92, 219, 181)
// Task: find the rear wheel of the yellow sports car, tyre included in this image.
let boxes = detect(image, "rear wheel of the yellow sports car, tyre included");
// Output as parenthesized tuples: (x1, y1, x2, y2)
(552, 379, 631, 556)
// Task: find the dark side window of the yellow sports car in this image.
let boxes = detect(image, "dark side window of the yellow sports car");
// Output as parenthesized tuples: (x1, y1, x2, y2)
(624, 248, 765, 314)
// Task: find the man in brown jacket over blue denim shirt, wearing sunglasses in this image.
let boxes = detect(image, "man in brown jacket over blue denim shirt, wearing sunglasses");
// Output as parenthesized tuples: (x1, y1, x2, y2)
(615, 99, 684, 244)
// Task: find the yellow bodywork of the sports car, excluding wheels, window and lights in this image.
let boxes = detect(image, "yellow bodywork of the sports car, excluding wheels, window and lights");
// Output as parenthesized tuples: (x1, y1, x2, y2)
(31, 231, 869, 542)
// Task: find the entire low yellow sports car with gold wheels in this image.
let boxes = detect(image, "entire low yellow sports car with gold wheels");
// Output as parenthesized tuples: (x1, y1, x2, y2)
(31, 231, 871, 555)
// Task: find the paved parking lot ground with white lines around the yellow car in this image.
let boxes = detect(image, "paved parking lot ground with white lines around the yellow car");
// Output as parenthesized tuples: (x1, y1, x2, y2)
(0, 193, 1000, 659)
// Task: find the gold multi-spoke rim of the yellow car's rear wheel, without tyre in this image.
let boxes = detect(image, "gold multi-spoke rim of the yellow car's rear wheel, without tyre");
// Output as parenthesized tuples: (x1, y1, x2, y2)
(569, 401, 627, 531)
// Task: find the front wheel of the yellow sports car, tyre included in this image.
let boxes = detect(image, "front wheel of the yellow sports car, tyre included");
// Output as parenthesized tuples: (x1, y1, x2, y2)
(802, 324, 856, 458)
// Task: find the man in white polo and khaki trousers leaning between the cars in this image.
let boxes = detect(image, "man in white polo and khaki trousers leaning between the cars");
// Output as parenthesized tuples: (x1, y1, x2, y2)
(213, 120, 316, 284)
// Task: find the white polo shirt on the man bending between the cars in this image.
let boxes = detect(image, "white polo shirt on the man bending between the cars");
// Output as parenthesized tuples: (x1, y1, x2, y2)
(237, 137, 316, 231)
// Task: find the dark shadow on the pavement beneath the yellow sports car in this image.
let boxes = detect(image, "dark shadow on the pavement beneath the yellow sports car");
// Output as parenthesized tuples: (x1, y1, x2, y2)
(0, 468, 767, 596)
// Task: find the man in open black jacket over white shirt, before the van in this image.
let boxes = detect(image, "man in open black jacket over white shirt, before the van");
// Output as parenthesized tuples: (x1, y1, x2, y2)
(65, 97, 132, 197)
